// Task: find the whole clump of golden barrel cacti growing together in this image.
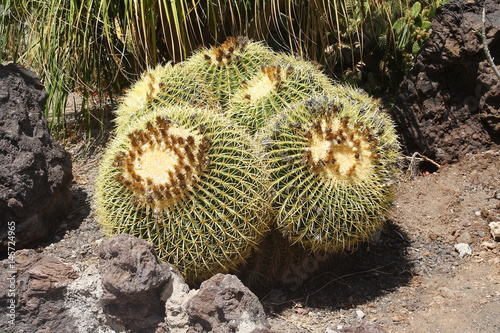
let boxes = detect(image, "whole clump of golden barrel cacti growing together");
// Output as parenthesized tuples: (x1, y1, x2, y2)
(94, 38, 399, 282)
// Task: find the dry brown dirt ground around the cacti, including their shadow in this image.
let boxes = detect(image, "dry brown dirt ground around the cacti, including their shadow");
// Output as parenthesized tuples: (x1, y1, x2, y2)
(38, 141, 500, 333)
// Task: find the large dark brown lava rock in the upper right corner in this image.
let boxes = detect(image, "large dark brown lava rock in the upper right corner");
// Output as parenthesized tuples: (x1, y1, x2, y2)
(394, 0, 500, 163)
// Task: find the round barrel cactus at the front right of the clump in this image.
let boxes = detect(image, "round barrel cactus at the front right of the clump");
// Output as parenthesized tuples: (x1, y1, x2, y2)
(258, 86, 399, 252)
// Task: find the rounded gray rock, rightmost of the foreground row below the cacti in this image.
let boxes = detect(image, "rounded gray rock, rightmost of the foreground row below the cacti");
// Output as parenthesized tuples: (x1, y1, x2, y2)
(187, 274, 269, 333)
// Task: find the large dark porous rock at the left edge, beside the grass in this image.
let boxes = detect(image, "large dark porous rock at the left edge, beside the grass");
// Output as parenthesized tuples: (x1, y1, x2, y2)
(0, 64, 73, 252)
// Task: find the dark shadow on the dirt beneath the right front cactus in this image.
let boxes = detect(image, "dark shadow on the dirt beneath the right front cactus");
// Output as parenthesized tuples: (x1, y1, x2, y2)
(252, 221, 414, 313)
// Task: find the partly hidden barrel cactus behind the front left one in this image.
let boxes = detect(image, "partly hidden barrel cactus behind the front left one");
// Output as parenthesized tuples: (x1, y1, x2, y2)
(115, 63, 219, 131)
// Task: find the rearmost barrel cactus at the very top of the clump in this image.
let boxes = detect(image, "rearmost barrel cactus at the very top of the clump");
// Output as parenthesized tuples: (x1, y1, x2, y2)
(184, 37, 275, 109)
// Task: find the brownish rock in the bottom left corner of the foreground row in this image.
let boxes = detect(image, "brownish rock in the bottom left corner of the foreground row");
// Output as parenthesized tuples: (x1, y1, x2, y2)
(0, 249, 79, 332)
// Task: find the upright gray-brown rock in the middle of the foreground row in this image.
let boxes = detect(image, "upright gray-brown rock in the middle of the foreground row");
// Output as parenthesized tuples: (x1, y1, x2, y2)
(99, 234, 172, 332)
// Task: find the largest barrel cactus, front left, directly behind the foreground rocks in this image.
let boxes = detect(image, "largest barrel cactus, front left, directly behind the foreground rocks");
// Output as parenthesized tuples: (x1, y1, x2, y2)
(95, 107, 270, 282)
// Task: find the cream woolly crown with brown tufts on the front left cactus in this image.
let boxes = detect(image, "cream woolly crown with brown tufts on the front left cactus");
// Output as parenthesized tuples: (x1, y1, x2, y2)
(114, 117, 210, 211)
